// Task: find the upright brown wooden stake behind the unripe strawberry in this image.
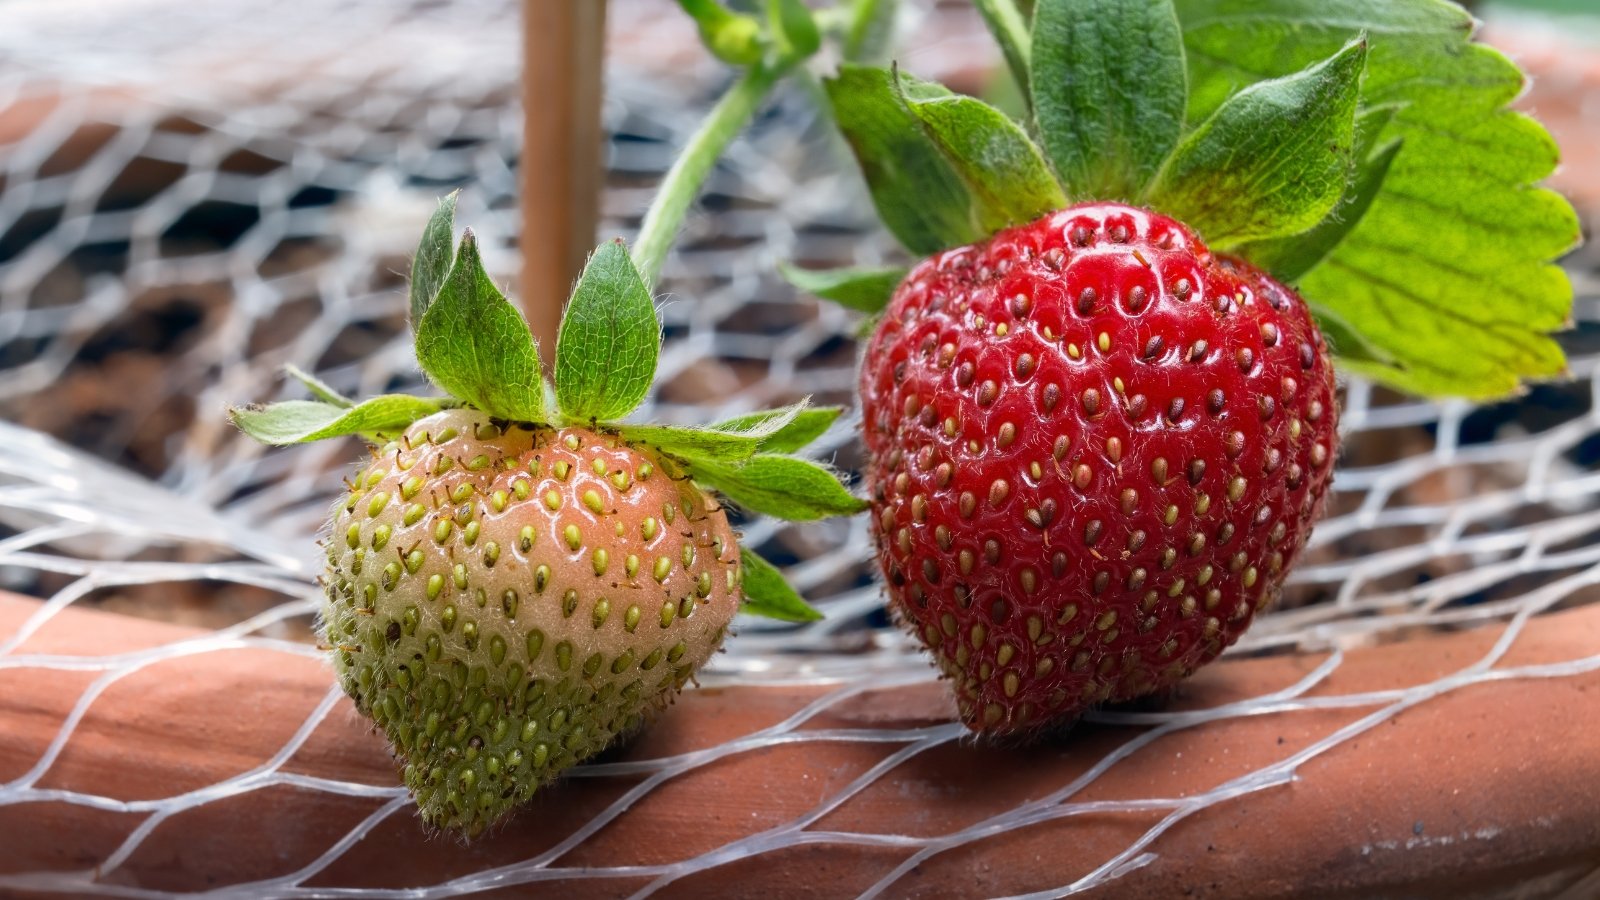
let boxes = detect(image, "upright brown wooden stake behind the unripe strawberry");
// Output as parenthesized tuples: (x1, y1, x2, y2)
(517, 0, 605, 368)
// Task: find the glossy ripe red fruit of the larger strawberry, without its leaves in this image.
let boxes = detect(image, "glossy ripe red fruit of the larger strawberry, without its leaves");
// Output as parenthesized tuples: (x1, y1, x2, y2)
(861, 203, 1338, 733)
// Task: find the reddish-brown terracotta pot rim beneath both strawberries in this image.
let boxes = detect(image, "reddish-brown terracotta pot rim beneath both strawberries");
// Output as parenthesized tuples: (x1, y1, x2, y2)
(0, 596, 1600, 898)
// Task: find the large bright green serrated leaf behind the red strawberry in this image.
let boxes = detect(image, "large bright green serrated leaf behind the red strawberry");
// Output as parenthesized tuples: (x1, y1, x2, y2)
(1178, 0, 1578, 397)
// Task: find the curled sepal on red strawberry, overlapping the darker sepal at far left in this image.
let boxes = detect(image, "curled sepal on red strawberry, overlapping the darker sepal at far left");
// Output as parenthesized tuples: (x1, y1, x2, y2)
(899, 75, 1067, 234)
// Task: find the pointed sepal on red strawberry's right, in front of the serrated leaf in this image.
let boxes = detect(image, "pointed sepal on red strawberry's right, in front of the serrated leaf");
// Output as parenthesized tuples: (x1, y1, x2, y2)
(1149, 38, 1366, 248)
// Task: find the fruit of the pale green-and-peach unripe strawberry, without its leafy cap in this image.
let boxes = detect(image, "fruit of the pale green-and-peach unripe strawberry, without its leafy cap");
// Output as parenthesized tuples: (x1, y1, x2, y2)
(323, 410, 741, 834)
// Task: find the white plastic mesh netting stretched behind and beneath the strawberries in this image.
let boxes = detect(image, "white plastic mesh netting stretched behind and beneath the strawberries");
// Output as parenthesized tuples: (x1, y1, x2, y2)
(0, 0, 1600, 897)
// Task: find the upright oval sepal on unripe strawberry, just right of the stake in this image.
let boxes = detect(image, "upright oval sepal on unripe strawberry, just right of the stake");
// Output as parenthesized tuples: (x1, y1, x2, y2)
(555, 240, 661, 421)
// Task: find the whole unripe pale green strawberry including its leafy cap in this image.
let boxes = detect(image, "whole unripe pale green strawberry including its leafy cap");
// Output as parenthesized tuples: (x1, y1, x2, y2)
(230, 204, 866, 836)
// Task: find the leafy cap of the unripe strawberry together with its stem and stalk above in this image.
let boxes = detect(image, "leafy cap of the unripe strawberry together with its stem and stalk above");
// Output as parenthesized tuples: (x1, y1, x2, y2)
(229, 0, 893, 620)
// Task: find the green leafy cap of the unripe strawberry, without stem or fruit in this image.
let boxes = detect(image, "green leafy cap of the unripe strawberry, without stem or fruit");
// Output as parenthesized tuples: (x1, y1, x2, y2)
(229, 195, 866, 620)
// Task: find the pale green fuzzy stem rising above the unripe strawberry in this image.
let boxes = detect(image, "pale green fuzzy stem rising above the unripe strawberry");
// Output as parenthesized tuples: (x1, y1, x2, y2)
(634, 59, 798, 285)
